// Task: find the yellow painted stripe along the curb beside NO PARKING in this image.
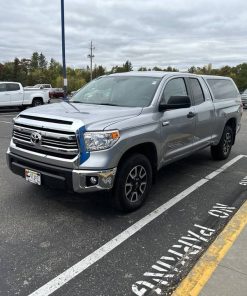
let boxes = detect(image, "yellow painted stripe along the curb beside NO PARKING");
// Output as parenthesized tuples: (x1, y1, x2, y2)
(172, 201, 247, 296)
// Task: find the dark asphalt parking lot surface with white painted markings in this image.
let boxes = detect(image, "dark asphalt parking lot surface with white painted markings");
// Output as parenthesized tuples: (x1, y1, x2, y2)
(0, 109, 247, 296)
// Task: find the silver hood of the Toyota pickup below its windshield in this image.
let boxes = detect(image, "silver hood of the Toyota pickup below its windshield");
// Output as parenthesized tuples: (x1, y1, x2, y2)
(21, 102, 142, 130)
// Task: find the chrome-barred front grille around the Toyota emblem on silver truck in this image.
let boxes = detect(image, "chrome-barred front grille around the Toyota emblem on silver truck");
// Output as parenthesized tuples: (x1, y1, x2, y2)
(13, 124, 79, 159)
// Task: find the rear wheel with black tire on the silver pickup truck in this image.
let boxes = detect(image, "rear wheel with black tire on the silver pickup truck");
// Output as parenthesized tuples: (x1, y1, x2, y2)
(211, 125, 234, 160)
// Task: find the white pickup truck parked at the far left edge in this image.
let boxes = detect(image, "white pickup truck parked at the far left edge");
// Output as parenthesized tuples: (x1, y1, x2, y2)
(0, 81, 50, 108)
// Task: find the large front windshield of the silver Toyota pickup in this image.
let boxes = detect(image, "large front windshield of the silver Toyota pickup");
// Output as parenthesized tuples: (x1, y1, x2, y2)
(70, 76, 161, 107)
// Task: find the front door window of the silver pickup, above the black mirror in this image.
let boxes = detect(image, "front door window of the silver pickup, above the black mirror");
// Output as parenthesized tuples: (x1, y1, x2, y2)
(162, 78, 188, 103)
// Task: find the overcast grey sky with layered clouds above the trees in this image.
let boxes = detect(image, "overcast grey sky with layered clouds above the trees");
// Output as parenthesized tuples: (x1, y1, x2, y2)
(0, 0, 247, 69)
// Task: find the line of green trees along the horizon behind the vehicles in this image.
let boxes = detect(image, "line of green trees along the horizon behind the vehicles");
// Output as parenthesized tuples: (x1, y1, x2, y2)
(0, 52, 247, 91)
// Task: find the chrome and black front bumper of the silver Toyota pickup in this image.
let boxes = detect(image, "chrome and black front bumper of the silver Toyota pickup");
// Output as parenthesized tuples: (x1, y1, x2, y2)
(6, 150, 117, 193)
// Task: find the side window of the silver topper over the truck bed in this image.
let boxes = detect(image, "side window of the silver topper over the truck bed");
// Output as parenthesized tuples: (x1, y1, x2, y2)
(207, 79, 239, 100)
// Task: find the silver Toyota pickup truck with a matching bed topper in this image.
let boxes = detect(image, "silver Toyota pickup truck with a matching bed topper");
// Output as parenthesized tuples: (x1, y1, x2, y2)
(7, 72, 243, 211)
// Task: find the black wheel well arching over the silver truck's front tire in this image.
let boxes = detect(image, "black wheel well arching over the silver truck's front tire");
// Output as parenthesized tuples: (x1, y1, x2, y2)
(119, 142, 158, 182)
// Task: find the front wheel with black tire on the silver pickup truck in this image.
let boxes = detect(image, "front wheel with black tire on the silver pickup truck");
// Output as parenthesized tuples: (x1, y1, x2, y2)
(113, 153, 152, 212)
